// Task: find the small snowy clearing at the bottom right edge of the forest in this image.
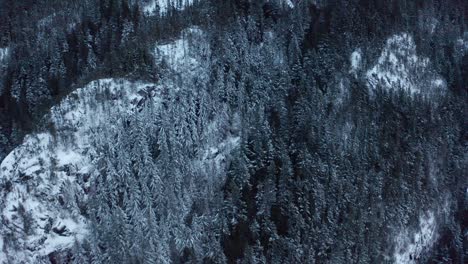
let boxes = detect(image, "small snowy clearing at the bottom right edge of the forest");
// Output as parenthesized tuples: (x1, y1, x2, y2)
(394, 212, 437, 264)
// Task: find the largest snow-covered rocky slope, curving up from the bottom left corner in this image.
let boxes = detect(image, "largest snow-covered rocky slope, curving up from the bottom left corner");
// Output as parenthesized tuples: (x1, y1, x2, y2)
(0, 79, 154, 263)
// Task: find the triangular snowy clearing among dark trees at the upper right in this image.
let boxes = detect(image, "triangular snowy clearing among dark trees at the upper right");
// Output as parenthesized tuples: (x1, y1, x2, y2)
(366, 33, 445, 94)
